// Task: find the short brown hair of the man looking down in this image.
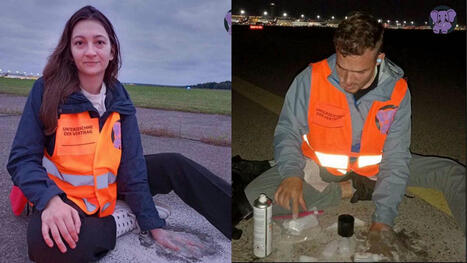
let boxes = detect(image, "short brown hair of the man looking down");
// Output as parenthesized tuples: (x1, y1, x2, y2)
(333, 12, 384, 57)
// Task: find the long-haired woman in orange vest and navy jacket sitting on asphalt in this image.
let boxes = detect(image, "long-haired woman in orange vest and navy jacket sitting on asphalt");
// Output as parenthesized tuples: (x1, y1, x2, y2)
(7, 6, 231, 262)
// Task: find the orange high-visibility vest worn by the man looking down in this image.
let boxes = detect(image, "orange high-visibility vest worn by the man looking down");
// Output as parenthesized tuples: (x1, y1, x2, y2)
(302, 60, 407, 176)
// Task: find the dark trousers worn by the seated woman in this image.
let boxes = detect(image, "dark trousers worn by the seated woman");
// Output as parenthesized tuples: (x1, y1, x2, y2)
(27, 153, 232, 263)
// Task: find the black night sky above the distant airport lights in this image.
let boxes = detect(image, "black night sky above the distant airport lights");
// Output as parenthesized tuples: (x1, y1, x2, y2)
(232, 0, 466, 25)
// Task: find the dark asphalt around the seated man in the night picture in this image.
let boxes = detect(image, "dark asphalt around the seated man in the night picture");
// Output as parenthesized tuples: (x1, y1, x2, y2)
(232, 25, 466, 262)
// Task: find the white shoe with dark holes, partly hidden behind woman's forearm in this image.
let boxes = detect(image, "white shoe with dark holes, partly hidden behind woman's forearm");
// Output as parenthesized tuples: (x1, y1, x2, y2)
(112, 200, 170, 237)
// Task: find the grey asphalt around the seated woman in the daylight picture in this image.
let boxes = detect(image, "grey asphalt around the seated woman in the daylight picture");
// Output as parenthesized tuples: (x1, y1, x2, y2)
(0, 98, 231, 262)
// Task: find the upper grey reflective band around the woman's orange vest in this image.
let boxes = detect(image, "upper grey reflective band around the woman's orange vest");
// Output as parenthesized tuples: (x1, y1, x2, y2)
(42, 156, 117, 189)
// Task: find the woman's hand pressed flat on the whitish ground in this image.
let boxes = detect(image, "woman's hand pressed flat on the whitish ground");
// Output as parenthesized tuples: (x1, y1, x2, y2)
(151, 228, 205, 257)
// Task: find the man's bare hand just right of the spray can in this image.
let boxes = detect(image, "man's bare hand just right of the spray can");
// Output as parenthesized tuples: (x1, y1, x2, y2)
(274, 177, 307, 219)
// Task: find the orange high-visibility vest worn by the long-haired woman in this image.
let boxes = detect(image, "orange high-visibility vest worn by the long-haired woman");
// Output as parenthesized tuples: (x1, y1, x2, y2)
(42, 112, 122, 217)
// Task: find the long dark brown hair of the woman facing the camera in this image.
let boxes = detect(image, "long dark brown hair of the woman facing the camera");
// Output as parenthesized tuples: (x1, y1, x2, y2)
(40, 6, 121, 135)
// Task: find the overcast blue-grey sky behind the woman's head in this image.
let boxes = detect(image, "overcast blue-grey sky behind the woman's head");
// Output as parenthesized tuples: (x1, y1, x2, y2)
(0, 0, 231, 85)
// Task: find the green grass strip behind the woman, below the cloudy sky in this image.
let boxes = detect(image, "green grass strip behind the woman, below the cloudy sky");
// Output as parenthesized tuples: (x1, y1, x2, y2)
(0, 77, 231, 115)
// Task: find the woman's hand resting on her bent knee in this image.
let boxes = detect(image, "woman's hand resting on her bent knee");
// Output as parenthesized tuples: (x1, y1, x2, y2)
(41, 195, 81, 253)
